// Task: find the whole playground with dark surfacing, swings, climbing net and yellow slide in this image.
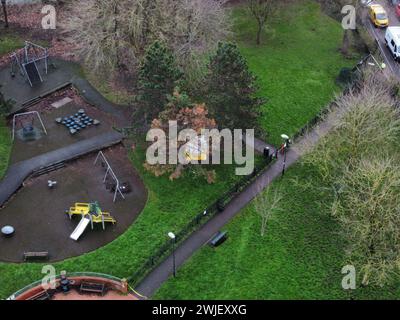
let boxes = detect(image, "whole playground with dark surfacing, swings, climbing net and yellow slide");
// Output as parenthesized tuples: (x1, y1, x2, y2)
(0, 42, 147, 262)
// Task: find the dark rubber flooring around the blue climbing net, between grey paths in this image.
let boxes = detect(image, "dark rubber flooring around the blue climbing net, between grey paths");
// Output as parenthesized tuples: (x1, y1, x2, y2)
(10, 102, 115, 163)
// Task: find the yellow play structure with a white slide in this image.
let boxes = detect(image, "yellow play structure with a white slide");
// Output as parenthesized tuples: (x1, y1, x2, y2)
(66, 202, 117, 241)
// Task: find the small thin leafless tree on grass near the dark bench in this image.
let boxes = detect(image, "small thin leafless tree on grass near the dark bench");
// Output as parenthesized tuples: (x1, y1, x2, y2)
(254, 181, 283, 237)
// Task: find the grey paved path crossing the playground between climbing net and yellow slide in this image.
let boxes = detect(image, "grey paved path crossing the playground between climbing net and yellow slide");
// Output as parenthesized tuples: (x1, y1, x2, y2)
(0, 131, 122, 207)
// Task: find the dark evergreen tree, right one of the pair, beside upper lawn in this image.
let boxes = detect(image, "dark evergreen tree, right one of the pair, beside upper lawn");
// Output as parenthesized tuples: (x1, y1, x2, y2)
(206, 43, 264, 130)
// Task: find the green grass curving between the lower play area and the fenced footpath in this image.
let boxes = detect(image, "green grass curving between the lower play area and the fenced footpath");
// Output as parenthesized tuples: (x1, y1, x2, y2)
(0, 149, 247, 298)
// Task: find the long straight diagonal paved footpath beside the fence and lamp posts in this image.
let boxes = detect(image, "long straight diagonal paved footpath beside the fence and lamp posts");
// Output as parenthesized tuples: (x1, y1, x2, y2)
(135, 110, 342, 297)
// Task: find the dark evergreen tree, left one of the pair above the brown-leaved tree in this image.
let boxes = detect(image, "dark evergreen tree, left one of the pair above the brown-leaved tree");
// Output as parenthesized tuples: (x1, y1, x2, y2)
(139, 41, 183, 123)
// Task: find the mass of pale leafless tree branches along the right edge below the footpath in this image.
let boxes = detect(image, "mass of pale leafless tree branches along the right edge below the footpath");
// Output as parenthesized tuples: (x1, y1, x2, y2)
(304, 72, 400, 285)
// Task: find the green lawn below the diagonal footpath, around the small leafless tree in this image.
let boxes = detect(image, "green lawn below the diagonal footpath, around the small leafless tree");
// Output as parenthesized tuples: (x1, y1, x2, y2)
(153, 164, 400, 300)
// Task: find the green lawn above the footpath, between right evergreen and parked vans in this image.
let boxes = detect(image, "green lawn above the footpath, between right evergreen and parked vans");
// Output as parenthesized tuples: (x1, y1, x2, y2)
(233, 0, 355, 144)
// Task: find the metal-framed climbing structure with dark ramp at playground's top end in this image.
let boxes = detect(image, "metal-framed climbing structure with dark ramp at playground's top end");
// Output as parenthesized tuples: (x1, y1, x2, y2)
(11, 41, 49, 87)
